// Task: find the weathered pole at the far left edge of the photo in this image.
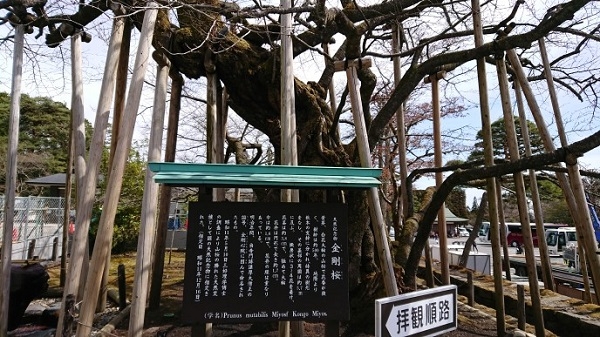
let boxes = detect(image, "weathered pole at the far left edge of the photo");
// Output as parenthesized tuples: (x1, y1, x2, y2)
(0, 25, 25, 337)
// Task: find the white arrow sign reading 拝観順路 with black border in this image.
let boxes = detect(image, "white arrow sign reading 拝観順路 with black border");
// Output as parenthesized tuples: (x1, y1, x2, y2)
(375, 285, 458, 337)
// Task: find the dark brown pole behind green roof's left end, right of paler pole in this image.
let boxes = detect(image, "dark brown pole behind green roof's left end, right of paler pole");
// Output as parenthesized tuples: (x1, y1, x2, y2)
(149, 72, 183, 309)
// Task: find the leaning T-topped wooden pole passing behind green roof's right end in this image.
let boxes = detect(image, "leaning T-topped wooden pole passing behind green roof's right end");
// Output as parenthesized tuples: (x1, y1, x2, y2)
(335, 59, 398, 296)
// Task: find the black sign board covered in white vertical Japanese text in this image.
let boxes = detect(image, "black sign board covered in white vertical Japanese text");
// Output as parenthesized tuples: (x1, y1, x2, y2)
(183, 202, 348, 323)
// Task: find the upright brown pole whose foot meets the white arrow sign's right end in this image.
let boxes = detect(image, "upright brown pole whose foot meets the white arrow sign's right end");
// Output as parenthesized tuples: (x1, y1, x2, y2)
(425, 72, 450, 284)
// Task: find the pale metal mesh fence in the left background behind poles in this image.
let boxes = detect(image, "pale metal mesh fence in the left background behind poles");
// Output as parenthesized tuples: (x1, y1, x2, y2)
(0, 196, 65, 260)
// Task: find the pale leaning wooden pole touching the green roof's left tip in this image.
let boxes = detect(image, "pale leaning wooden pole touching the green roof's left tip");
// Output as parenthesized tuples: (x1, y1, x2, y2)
(128, 52, 171, 337)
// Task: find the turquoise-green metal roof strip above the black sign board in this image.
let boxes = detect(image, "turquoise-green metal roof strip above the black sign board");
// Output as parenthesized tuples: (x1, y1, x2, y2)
(148, 163, 381, 188)
